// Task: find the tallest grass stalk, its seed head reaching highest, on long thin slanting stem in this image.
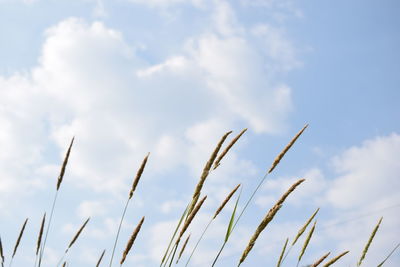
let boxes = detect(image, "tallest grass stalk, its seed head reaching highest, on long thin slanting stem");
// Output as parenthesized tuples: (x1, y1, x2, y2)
(212, 124, 308, 266)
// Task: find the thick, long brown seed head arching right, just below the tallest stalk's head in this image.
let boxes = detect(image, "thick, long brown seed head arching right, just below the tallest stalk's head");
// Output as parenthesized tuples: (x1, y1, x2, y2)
(238, 179, 305, 266)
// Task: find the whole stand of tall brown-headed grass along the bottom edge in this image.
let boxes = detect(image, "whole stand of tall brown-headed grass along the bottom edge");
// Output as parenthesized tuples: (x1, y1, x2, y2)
(0, 128, 394, 267)
